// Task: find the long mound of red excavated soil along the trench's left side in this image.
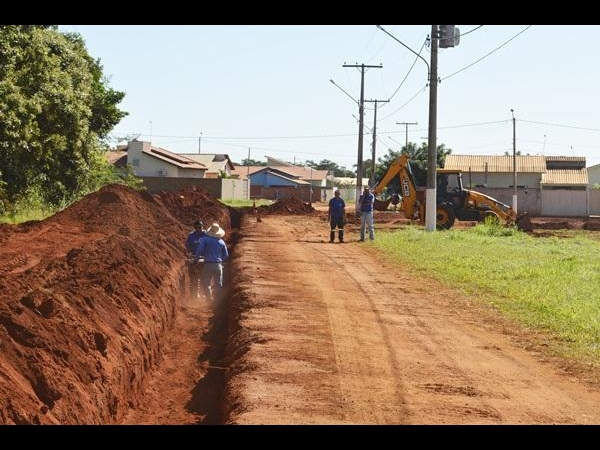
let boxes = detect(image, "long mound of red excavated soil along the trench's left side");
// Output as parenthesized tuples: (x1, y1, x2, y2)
(0, 185, 231, 424)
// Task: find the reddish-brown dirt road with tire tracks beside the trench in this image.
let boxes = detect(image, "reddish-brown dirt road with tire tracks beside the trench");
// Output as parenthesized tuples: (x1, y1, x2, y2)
(220, 209, 600, 424)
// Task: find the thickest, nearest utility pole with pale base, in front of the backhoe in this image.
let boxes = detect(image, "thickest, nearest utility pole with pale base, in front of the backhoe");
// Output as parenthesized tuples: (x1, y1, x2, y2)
(425, 25, 438, 231)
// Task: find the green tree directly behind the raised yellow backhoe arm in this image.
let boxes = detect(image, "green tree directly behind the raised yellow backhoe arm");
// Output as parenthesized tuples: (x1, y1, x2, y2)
(375, 142, 452, 194)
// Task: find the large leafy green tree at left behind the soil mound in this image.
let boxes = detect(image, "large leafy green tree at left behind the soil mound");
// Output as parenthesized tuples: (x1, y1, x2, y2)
(0, 25, 127, 204)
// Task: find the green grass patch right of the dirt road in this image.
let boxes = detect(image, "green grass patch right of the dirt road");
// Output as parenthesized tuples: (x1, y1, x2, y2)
(373, 225, 600, 363)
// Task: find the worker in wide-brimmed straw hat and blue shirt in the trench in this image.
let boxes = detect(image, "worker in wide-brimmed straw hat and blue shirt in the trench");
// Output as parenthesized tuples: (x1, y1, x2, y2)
(194, 222, 229, 302)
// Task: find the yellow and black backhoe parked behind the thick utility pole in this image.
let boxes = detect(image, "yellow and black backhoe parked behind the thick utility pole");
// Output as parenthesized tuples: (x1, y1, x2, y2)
(373, 154, 533, 231)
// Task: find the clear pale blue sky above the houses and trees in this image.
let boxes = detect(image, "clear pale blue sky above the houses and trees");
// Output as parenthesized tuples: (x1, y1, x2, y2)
(59, 25, 600, 169)
